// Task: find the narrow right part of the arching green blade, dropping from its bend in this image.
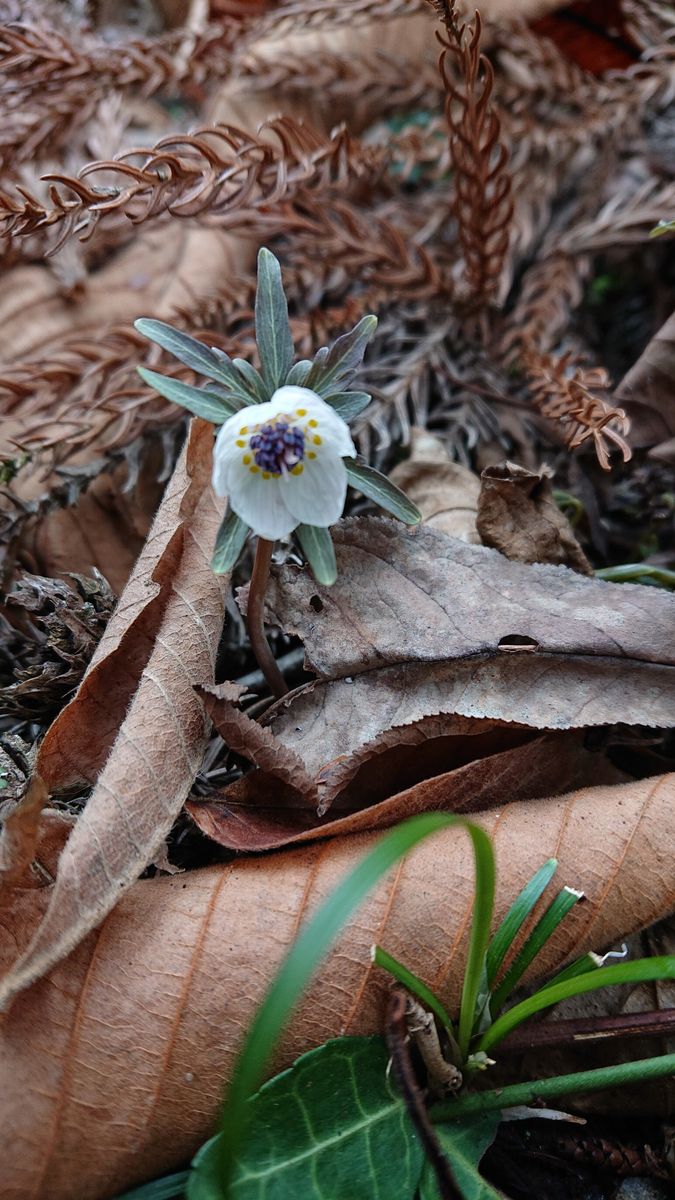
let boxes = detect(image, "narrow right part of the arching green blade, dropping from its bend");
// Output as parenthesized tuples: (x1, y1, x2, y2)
(458, 824, 496, 1066)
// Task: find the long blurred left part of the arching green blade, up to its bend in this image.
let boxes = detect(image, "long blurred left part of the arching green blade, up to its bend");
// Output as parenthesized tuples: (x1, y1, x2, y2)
(214, 812, 478, 1196)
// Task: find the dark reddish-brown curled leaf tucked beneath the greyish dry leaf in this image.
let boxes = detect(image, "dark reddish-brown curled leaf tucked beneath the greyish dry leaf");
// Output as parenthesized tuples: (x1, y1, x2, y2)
(186, 716, 621, 851)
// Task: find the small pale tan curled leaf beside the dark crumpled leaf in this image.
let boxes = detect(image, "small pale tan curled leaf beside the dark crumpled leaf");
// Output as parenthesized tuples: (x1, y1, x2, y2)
(392, 427, 480, 544)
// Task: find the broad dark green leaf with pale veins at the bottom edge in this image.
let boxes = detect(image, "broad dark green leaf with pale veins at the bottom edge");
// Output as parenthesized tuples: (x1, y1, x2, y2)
(187, 1038, 424, 1200)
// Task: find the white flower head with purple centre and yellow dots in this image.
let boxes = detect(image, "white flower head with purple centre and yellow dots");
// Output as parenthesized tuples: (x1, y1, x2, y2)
(213, 385, 357, 541)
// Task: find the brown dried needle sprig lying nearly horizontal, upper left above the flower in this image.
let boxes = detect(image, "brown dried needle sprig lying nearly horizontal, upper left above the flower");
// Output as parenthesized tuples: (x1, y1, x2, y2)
(0, 116, 386, 253)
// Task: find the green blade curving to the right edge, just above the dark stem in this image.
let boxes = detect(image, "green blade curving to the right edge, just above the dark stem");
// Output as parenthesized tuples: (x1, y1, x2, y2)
(477, 955, 675, 1052)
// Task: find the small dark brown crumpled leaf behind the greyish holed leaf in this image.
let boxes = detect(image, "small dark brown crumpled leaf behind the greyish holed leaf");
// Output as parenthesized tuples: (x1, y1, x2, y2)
(477, 462, 593, 575)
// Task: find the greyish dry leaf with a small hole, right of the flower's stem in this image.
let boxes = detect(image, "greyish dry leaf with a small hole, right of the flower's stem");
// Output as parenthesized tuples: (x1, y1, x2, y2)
(264, 517, 675, 733)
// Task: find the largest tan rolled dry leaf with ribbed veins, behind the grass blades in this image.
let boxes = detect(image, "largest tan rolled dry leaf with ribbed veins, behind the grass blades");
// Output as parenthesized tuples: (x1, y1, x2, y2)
(0, 775, 675, 1200)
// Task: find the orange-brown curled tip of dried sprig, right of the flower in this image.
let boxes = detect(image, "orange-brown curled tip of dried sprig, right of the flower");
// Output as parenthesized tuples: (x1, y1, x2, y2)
(524, 347, 632, 470)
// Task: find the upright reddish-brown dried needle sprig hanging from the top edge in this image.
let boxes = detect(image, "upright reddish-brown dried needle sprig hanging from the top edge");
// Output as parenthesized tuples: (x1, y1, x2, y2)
(436, 0, 513, 308)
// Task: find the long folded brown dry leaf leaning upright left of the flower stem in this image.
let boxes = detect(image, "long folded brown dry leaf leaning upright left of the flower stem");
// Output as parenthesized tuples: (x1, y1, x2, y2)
(0, 421, 223, 1002)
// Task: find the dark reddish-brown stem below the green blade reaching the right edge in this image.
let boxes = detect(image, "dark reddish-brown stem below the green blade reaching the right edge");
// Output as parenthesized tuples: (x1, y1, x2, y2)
(500, 1008, 675, 1054)
